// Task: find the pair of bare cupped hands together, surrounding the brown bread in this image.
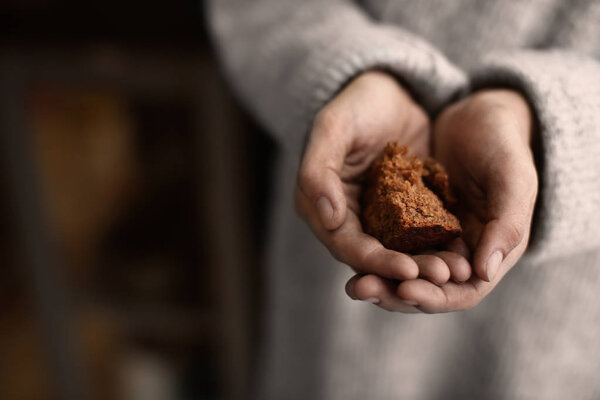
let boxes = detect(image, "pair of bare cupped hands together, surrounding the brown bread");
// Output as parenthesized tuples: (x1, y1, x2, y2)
(296, 72, 537, 313)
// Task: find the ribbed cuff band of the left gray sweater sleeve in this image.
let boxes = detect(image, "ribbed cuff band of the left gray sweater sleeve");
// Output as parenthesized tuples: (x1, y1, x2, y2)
(294, 26, 466, 119)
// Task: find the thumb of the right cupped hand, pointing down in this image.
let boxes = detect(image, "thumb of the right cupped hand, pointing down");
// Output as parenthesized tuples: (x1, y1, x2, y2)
(473, 162, 537, 282)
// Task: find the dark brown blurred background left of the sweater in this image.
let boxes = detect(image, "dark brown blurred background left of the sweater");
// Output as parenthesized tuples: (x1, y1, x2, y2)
(0, 0, 275, 400)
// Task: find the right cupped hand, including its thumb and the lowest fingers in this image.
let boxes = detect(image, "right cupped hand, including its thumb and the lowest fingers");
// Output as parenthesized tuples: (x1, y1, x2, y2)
(347, 90, 538, 313)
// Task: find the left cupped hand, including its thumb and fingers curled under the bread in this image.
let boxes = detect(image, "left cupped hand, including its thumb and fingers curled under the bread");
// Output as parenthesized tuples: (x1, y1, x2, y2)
(296, 72, 470, 308)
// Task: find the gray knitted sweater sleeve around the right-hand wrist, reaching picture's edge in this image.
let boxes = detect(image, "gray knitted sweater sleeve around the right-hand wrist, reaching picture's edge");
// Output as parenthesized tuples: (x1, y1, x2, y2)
(471, 50, 600, 262)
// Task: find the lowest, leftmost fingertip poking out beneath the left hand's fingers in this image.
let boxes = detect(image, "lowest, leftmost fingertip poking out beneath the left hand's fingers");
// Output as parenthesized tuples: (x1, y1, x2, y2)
(346, 275, 420, 313)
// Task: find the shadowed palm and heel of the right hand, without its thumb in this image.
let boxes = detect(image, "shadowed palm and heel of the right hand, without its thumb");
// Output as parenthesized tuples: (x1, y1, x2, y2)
(433, 93, 531, 260)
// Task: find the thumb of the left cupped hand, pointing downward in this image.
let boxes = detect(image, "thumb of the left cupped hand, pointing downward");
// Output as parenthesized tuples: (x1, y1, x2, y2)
(298, 113, 347, 230)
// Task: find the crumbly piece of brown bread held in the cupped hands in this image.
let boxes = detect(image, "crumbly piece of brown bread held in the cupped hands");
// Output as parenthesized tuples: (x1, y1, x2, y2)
(362, 142, 461, 253)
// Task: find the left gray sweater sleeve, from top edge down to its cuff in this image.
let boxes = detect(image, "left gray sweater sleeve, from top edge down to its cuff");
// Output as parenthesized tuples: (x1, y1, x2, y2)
(207, 0, 466, 158)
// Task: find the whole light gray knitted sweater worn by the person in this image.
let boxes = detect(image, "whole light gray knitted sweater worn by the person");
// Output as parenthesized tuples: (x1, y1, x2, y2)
(209, 0, 600, 400)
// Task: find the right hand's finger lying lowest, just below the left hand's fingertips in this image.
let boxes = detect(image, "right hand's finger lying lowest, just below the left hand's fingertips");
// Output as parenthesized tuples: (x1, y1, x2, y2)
(396, 279, 490, 313)
